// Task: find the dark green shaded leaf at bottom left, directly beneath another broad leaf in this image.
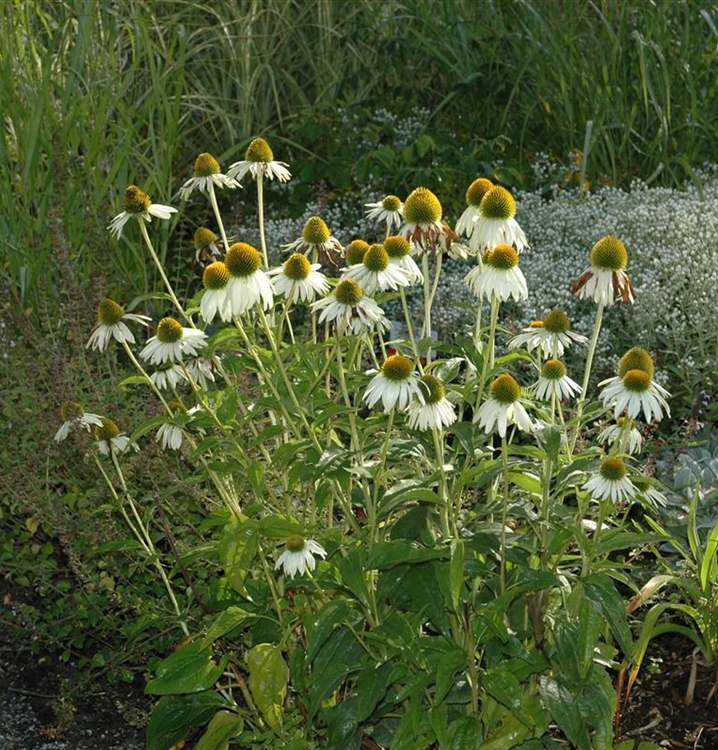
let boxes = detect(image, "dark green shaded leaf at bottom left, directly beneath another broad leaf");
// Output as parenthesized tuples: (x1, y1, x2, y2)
(146, 690, 226, 750)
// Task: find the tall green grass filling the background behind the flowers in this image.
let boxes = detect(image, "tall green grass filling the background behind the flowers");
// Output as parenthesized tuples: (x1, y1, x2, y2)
(0, 0, 718, 307)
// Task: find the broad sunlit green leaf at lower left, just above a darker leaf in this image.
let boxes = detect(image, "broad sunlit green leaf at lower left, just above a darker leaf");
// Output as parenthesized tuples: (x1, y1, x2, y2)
(145, 641, 226, 695)
